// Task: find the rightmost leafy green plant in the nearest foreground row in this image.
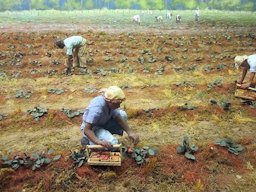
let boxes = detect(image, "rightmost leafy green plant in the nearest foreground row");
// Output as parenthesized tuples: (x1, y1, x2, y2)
(216, 138, 244, 155)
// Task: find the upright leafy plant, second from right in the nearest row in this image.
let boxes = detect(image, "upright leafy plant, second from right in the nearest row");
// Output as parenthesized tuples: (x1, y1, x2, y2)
(176, 136, 198, 161)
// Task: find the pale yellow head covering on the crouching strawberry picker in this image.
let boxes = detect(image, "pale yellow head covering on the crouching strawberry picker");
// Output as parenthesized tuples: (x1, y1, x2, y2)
(103, 86, 125, 103)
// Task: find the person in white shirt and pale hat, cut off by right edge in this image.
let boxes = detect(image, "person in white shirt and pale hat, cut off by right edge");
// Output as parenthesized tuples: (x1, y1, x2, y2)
(235, 54, 256, 89)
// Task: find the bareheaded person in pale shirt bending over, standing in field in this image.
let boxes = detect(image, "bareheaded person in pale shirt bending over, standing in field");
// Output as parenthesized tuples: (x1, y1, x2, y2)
(55, 36, 86, 74)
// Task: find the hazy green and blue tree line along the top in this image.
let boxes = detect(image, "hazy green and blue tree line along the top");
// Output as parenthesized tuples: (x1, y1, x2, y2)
(0, 0, 256, 11)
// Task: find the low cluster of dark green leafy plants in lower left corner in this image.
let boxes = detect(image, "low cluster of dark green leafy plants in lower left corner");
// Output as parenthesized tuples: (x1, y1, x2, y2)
(2, 149, 61, 171)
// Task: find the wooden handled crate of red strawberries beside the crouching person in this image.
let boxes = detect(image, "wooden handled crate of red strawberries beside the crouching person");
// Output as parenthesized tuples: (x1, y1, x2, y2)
(86, 144, 122, 166)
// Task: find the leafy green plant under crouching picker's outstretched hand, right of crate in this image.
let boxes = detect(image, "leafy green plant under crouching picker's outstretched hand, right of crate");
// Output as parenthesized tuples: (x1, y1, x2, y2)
(123, 146, 157, 165)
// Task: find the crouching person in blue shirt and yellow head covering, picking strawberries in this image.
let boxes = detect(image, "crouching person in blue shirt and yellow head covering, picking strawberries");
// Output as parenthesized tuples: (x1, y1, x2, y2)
(81, 86, 139, 148)
